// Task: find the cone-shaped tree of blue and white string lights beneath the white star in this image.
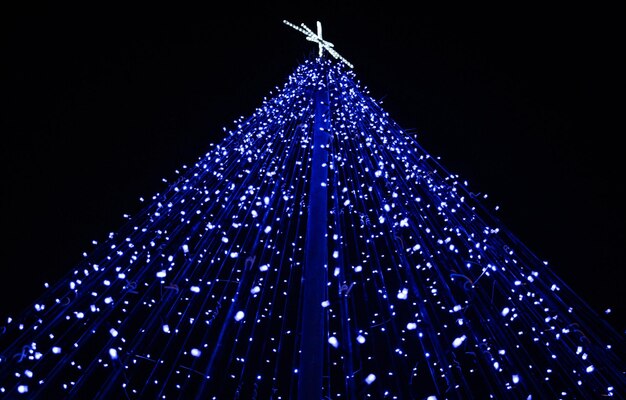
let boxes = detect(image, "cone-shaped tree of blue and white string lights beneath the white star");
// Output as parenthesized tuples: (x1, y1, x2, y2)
(0, 21, 626, 400)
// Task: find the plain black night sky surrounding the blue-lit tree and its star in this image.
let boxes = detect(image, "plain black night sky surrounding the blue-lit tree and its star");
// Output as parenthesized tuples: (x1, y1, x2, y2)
(0, 4, 626, 331)
